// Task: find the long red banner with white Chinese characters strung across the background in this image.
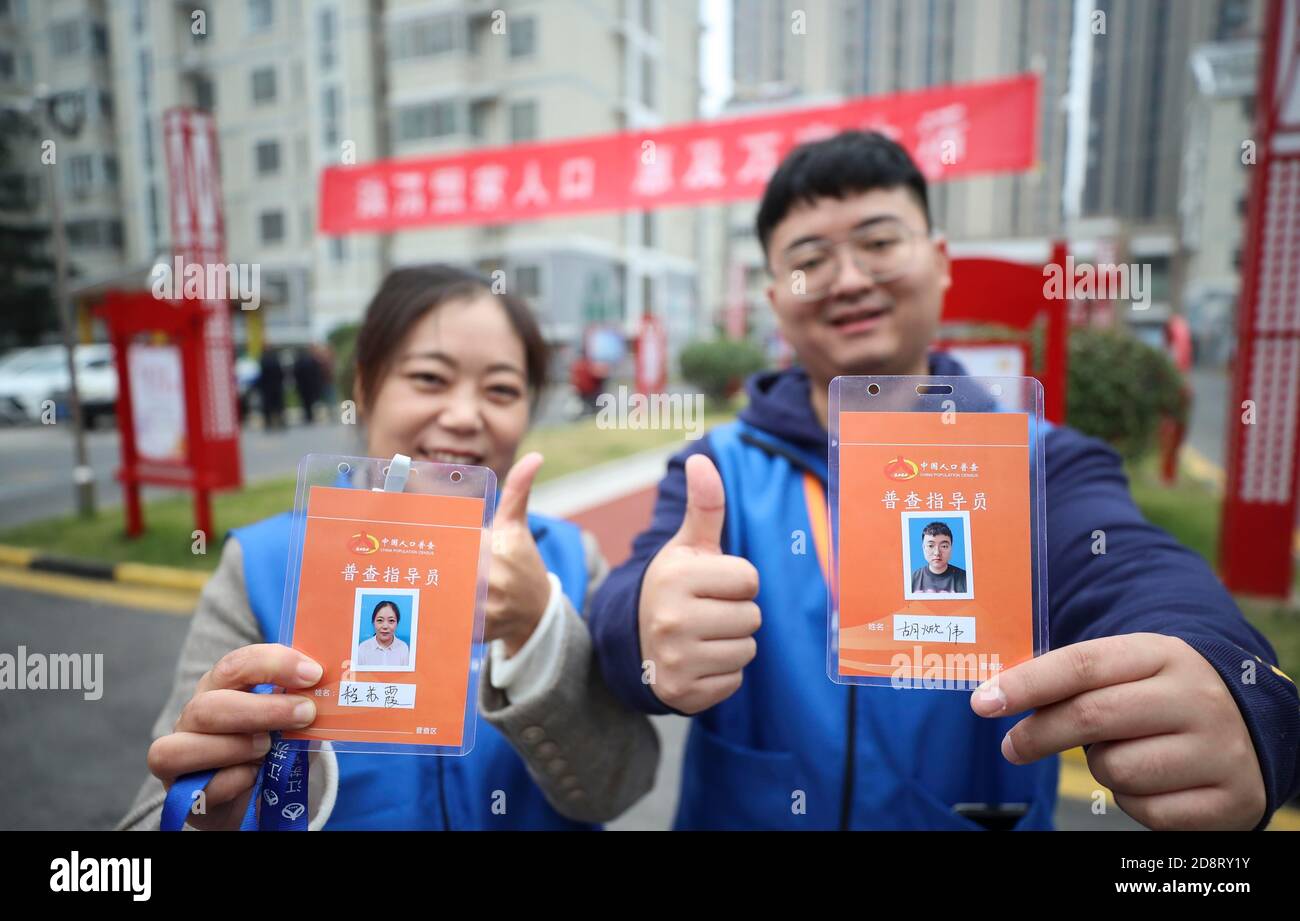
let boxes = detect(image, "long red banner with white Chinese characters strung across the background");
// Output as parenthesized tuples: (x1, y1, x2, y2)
(320, 74, 1039, 235)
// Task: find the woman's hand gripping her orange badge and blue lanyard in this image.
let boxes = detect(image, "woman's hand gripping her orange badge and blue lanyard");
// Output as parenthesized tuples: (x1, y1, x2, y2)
(148, 643, 322, 830)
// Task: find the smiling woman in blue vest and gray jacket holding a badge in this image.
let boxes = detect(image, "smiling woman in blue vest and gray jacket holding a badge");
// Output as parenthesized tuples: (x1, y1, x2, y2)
(122, 265, 659, 830)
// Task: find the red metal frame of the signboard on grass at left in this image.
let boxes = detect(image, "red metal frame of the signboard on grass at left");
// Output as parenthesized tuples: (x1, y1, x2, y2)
(95, 291, 241, 537)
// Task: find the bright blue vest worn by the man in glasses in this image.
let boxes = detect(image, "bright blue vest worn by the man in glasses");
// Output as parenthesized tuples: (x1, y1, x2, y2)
(676, 421, 1058, 830)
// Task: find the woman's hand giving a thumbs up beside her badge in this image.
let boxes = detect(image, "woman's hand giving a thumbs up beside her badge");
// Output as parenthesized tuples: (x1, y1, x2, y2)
(484, 451, 551, 656)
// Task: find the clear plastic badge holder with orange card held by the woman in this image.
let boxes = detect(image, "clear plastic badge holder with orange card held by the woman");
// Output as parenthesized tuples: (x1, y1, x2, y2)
(280, 454, 497, 754)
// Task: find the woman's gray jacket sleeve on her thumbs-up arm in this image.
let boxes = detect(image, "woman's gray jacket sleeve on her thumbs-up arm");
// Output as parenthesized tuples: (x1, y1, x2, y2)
(478, 532, 659, 822)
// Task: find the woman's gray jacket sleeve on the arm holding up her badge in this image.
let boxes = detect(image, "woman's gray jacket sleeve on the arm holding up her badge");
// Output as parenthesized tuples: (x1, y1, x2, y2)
(117, 537, 334, 831)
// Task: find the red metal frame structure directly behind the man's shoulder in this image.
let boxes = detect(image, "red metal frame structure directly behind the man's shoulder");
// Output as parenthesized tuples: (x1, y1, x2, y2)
(944, 241, 1070, 423)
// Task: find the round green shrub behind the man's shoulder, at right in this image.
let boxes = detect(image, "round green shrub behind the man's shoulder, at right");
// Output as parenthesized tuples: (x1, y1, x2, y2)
(1066, 329, 1187, 459)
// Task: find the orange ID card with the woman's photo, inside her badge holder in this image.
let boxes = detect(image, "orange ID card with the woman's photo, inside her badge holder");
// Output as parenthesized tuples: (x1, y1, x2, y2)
(283, 485, 485, 753)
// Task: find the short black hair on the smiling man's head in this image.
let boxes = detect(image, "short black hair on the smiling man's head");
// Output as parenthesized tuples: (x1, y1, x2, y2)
(754, 131, 930, 256)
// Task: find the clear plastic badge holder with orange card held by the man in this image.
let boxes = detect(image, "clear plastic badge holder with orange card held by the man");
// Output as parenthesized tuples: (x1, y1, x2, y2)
(827, 376, 1048, 689)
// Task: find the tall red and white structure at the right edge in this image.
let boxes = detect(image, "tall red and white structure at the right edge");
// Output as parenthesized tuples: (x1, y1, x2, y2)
(1219, 0, 1300, 597)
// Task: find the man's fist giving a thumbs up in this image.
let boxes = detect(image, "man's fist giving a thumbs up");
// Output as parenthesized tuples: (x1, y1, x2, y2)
(638, 454, 762, 713)
